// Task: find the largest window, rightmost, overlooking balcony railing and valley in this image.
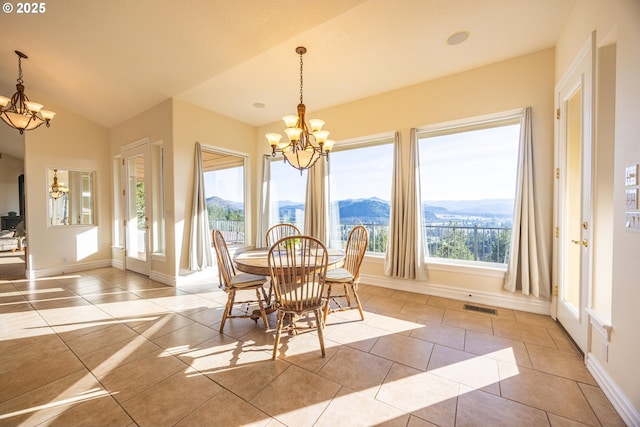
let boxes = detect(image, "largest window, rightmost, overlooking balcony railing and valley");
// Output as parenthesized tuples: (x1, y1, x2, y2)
(418, 113, 521, 264)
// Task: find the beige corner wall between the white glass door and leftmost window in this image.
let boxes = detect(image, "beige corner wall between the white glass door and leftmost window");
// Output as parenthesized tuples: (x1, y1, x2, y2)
(110, 99, 257, 284)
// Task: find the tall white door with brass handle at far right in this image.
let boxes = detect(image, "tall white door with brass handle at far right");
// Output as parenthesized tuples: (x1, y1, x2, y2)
(554, 34, 593, 352)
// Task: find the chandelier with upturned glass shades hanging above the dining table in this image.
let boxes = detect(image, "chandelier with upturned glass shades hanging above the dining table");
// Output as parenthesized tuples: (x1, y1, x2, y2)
(265, 46, 335, 173)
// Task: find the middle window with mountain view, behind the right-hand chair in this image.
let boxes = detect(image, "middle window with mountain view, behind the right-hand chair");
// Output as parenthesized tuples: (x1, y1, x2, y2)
(329, 136, 393, 253)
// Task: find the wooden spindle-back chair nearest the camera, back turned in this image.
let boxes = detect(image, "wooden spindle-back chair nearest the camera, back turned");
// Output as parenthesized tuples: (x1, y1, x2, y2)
(268, 236, 329, 360)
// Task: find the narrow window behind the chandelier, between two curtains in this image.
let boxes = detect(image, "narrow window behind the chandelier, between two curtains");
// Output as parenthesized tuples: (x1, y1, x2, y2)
(269, 157, 306, 230)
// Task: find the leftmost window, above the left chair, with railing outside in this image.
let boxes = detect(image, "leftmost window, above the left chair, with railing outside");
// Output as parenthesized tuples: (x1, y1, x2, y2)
(202, 150, 245, 245)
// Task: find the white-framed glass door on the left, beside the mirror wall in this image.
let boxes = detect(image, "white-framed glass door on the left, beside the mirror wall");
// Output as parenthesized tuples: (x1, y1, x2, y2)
(122, 142, 150, 276)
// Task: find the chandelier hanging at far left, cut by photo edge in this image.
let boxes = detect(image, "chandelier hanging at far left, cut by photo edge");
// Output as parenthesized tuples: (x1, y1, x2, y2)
(0, 50, 56, 135)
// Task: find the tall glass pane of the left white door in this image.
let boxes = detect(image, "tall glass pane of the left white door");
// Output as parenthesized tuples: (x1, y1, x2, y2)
(127, 156, 147, 261)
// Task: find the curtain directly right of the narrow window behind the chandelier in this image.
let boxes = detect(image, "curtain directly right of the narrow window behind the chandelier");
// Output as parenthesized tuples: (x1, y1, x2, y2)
(304, 158, 329, 245)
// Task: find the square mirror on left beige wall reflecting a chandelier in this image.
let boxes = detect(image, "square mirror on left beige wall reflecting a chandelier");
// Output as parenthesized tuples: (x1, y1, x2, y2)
(47, 169, 95, 225)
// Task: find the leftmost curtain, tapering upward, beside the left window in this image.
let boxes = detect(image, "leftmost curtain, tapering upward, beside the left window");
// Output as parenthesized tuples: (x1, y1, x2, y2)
(189, 142, 213, 271)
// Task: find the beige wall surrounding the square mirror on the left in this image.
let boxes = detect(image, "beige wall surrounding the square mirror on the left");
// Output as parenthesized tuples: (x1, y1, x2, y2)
(24, 98, 111, 276)
